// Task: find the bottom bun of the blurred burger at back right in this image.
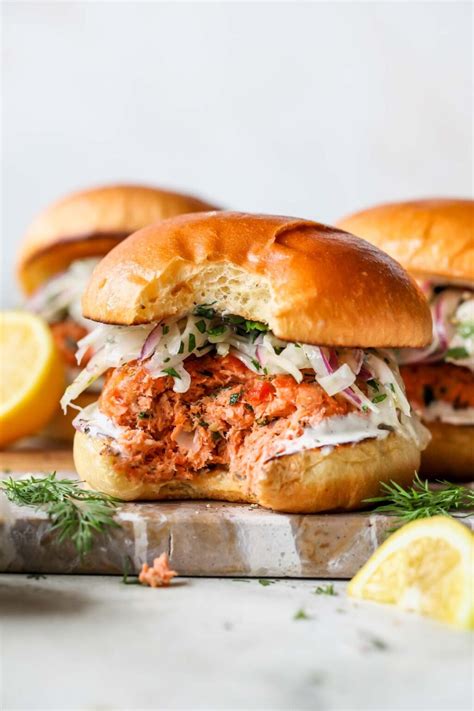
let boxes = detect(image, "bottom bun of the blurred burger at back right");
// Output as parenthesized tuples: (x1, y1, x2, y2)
(421, 422, 474, 481)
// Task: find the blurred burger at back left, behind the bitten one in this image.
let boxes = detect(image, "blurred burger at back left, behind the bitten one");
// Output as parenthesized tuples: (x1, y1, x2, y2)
(18, 185, 214, 438)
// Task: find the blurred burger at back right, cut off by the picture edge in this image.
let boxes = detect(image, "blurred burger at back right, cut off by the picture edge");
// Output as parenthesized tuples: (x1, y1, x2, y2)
(339, 199, 474, 480)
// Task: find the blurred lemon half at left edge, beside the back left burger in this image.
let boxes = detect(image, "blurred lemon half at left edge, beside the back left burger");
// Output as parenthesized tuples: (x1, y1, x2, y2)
(0, 311, 64, 446)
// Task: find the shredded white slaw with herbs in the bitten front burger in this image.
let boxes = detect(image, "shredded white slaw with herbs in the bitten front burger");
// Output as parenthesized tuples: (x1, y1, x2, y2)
(61, 307, 411, 436)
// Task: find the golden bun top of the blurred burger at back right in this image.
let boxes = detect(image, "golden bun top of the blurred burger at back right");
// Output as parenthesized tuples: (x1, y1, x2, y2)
(337, 198, 474, 282)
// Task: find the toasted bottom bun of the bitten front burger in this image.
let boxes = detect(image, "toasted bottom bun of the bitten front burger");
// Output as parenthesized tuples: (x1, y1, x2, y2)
(74, 432, 420, 513)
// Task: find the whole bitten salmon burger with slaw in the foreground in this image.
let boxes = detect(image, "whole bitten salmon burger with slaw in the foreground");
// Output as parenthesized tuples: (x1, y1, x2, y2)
(62, 212, 431, 512)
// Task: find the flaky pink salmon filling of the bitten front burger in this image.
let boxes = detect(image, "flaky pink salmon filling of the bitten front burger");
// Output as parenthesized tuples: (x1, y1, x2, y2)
(99, 355, 356, 480)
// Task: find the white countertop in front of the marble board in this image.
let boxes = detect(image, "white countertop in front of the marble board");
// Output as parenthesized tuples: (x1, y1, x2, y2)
(0, 575, 473, 711)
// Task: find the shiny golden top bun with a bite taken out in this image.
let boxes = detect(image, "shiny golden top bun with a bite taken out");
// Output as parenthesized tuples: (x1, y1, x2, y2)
(82, 212, 431, 347)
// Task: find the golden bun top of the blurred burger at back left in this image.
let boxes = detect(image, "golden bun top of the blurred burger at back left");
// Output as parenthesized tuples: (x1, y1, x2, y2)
(18, 185, 216, 294)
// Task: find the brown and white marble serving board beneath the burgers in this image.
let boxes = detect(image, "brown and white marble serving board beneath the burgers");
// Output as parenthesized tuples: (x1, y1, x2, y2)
(0, 448, 474, 579)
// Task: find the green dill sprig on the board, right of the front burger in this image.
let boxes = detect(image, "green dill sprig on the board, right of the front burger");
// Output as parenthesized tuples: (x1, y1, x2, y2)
(364, 474, 474, 525)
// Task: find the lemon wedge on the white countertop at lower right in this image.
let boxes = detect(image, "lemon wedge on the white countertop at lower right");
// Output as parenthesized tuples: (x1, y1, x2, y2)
(348, 516, 474, 628)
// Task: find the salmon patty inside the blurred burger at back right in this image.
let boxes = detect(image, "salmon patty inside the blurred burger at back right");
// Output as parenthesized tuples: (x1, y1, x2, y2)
(400, 363, 474, 410)
